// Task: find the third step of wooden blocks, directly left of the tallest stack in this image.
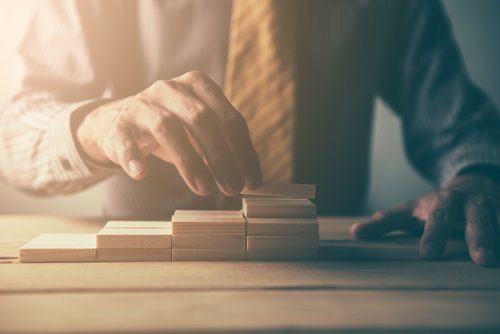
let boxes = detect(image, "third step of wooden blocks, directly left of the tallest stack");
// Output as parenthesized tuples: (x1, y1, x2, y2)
(172, 210, 245, 261)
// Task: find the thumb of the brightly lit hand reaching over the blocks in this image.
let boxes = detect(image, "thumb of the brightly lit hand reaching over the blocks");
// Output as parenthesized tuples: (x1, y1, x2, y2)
(102, 122, 148, 180)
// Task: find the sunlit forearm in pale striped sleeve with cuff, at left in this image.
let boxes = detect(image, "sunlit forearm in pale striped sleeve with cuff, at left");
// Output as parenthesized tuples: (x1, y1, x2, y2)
(0, 94, 111, 195)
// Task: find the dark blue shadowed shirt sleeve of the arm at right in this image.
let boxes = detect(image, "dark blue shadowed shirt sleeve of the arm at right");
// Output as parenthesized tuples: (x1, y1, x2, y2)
(380, 0, 500, 186)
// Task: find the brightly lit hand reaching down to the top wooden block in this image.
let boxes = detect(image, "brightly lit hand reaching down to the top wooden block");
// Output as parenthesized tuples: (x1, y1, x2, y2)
(76, 71, 262, 195)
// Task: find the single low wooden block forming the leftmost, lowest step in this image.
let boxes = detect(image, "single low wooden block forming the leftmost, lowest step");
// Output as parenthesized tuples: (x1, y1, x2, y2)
(19, 233, 96, 262)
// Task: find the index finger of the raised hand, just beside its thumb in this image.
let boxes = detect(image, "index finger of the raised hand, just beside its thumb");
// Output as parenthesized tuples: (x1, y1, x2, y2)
(141, 105, 215, 196)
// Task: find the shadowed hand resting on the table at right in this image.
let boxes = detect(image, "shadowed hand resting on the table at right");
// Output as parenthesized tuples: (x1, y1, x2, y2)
(351, 174, 500, 266)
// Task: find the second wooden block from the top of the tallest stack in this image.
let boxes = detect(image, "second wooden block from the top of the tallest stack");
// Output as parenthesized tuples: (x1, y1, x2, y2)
(243, 197, 316, 218)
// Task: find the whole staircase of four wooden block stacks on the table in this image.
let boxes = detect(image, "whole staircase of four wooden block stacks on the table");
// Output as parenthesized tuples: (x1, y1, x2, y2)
(19, 184, 319, 262)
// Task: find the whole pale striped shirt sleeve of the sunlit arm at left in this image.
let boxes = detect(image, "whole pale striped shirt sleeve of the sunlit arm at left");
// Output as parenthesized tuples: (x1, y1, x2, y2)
(0, 1, 116, 195)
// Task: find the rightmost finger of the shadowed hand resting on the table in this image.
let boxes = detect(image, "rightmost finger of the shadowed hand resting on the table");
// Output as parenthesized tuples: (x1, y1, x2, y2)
(465, 195, 496, 266)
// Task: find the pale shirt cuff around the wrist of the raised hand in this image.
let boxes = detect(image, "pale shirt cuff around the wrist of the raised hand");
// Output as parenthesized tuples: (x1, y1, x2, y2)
(48, 99, 116, 181)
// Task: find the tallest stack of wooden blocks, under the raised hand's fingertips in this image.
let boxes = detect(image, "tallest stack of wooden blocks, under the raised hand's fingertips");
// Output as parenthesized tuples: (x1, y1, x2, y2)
(243, 184, 319, 261)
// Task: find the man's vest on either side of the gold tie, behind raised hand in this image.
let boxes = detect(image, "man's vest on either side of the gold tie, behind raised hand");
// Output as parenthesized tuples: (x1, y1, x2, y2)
(105, 0, 389, 219)
